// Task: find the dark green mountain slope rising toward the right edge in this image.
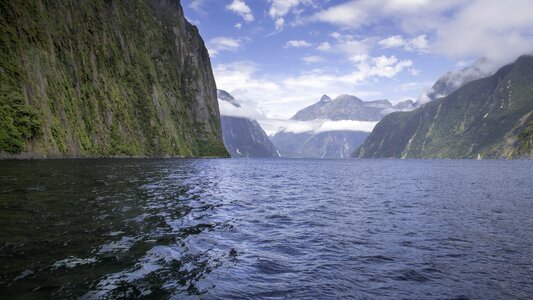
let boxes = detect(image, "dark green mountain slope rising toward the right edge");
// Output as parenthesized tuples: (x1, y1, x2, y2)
(354, 56, 533, 159)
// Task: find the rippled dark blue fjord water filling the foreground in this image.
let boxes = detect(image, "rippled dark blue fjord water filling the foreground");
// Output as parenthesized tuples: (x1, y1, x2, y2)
(0, 159, 533, 299)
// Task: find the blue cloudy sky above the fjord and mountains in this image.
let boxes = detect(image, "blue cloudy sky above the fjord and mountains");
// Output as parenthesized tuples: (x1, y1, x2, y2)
(182, 0, 533, 133)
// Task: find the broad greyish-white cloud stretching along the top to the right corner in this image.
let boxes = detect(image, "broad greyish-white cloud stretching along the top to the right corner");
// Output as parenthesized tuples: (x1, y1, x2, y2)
(301, 0, 533, 64)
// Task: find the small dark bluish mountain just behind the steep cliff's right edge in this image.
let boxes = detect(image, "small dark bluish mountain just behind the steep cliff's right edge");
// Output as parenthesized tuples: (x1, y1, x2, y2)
(217, 90, 280, 157)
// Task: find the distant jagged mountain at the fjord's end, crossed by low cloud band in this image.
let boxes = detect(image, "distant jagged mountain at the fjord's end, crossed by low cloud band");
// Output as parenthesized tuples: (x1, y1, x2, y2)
(271, 95, 415, 158)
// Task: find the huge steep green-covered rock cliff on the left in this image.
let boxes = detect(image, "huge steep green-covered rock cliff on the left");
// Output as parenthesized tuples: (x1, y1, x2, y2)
(0, 0, 227, 157)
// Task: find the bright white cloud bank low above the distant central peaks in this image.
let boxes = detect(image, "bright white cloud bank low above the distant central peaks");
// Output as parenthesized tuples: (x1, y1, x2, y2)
(213, 56, 412, 124)
